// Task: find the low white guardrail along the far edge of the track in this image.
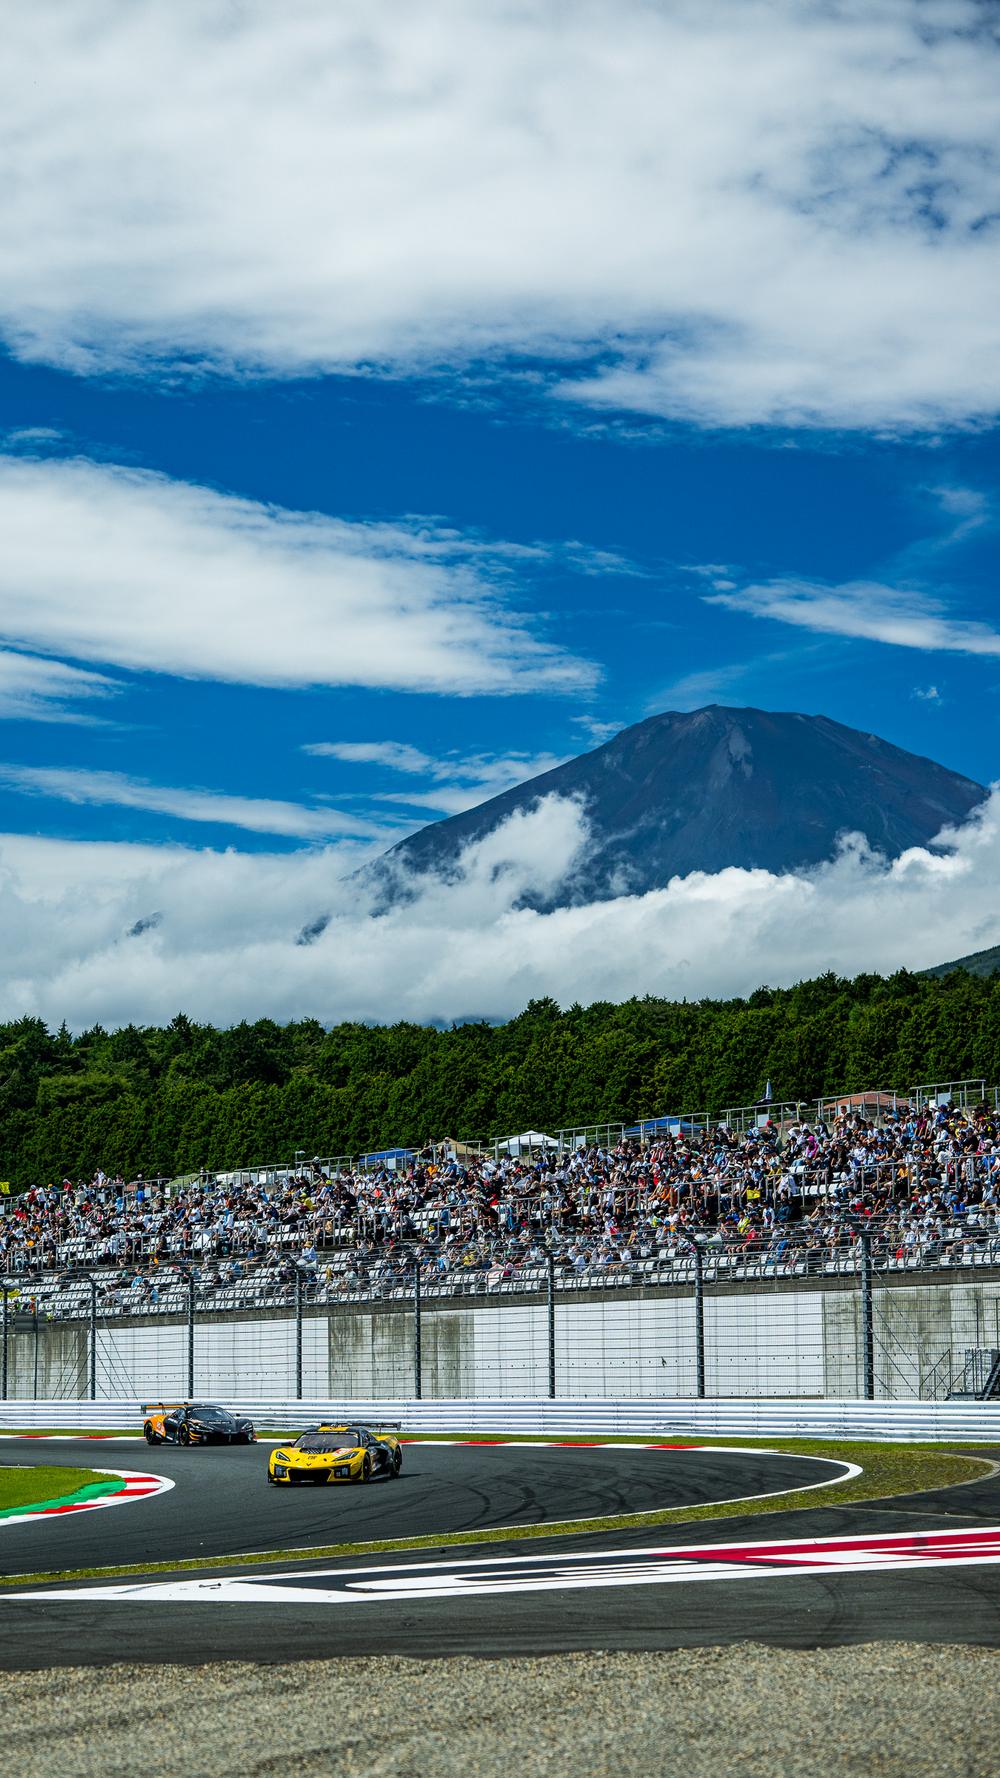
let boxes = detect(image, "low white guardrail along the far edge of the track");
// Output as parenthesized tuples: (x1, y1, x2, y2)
(0, 1396, 1000, 1444)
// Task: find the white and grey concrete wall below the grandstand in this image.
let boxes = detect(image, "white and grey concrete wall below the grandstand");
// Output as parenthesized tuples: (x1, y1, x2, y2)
(7, 1282, 1000, 1399)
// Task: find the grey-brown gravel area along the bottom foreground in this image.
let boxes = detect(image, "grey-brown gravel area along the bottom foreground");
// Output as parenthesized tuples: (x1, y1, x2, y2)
(0, 1643, 1000, 1778)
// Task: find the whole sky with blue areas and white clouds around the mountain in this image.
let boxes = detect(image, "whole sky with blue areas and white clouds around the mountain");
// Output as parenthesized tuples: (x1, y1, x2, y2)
(0, 0, 1000, 1021)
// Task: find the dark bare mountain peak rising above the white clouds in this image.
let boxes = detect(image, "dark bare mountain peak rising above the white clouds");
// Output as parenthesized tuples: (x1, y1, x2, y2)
(379, 704, 986, 900)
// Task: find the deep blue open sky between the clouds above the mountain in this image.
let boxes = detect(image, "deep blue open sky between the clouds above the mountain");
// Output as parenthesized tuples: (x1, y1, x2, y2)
(0, 359, 1000, 848)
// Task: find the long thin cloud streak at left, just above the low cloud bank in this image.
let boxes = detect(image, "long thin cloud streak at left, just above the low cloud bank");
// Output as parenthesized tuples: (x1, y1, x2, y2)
(0, 765, 399, 843)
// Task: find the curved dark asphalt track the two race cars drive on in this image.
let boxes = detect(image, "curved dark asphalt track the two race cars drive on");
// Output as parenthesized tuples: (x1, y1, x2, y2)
(0, 1438, 842, 1575)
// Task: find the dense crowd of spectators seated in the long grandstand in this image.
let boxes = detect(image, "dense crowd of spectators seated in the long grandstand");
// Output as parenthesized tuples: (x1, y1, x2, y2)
(0, 1104, 1000, 1310)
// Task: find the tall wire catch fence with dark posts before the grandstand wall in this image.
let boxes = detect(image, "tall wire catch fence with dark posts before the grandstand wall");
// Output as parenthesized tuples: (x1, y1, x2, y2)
(0, 1227, 1000, 1401)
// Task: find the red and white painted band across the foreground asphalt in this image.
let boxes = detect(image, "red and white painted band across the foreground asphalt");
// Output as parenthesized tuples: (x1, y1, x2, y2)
(21, 1526, 1000, 1607)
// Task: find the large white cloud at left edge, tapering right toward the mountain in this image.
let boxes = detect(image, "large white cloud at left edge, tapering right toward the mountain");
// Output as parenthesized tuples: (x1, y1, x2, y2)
(0, 457, 594, 695)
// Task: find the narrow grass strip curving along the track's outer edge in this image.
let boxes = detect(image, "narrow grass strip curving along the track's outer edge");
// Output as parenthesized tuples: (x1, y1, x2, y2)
(4, 1435, 995, 1588)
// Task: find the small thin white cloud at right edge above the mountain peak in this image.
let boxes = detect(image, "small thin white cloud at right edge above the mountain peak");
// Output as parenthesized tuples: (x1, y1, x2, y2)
(705, 580, 1000, 654)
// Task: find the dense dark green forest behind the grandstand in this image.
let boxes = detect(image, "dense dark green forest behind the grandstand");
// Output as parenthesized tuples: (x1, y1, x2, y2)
(0, 973, 1000, 1191)
